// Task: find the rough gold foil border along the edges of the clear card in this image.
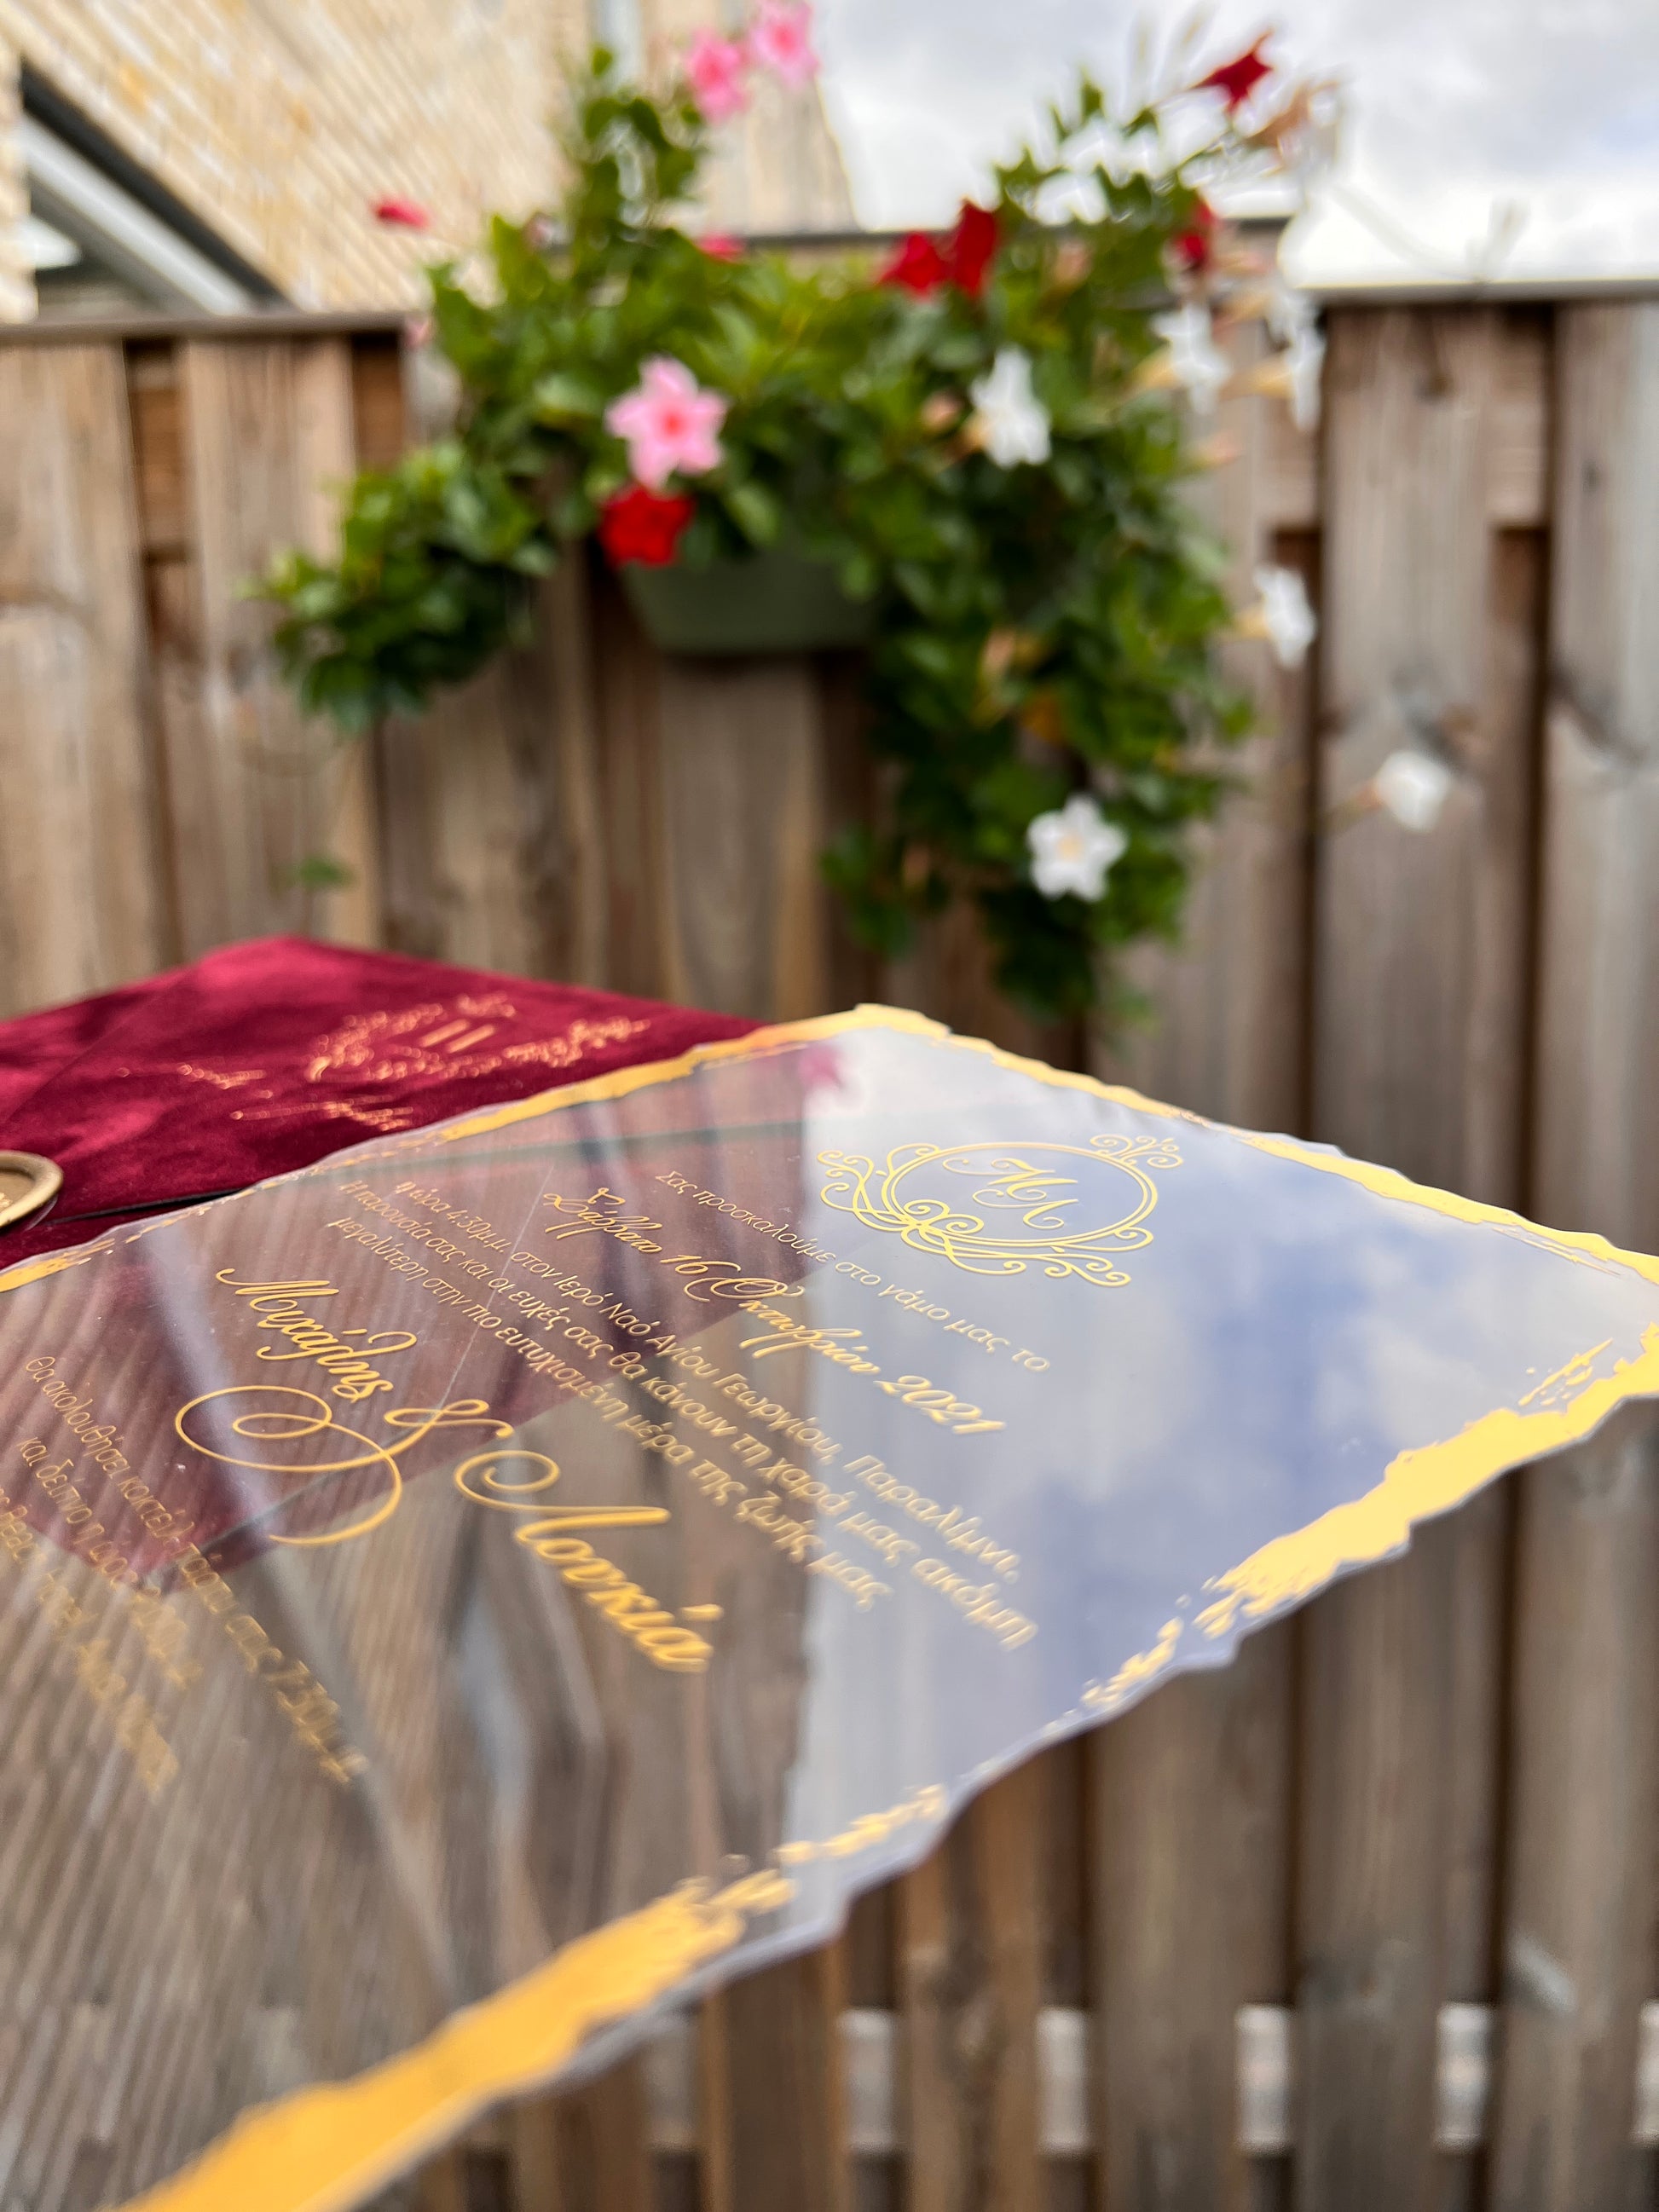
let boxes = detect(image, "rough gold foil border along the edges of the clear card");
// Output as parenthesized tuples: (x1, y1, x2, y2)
(0, 1007, 1659, 2212)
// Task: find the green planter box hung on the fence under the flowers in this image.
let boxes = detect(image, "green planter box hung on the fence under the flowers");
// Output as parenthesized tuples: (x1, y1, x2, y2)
(617, 549, 874, 655)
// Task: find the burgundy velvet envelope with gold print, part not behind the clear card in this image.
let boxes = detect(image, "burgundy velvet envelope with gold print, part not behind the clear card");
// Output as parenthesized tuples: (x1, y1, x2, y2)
(0, 938, 754, 1268)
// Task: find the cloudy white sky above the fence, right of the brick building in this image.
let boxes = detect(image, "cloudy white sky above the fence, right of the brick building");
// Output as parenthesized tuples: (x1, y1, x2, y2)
(816, 0, 1659, 281)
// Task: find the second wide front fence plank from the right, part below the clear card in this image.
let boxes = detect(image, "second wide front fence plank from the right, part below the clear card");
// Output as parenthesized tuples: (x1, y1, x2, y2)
(1296, 1493, 1506, 2212)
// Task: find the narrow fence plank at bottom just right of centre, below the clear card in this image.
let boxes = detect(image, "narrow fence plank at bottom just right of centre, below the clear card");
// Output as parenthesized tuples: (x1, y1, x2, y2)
(898, 1761, 1049, 2212)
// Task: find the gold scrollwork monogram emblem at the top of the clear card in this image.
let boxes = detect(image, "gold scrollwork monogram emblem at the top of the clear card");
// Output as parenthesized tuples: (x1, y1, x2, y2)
(818, 1135, 1182, 1290)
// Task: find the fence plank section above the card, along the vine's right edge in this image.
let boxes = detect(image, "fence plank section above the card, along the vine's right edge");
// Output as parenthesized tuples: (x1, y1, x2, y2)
(1106, 325, 1318, 1130)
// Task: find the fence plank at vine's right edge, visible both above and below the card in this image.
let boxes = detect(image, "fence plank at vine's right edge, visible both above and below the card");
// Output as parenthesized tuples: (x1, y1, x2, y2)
(1089, 338, 1318, 2212)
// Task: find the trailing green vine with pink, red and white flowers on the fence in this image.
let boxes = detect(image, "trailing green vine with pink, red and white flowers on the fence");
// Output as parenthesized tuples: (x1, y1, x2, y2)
(265, 23, 1318, 1015)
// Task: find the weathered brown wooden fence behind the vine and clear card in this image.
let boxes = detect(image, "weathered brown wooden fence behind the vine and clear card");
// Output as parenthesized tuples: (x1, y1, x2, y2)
(0, 292, 1659, 2212)
